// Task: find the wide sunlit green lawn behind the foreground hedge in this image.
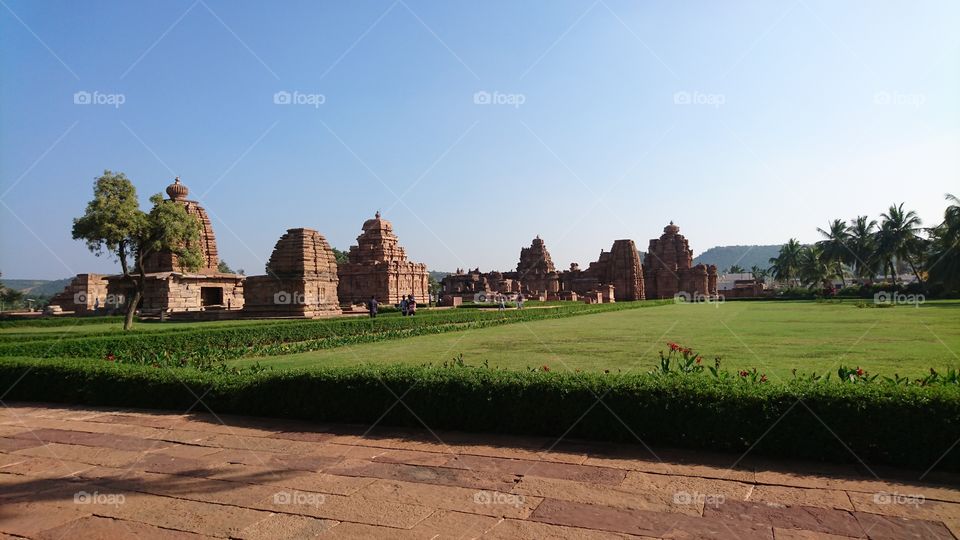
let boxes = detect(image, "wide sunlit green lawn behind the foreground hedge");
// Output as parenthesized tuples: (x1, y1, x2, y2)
(231, 301, 960, 380)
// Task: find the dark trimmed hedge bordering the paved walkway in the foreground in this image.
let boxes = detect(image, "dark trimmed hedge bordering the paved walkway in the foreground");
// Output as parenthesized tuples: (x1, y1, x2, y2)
(0, 359, 960, 471)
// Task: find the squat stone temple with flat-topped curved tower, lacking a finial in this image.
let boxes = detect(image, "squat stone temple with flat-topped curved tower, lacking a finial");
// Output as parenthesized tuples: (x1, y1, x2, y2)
(243, 228, 340, 318)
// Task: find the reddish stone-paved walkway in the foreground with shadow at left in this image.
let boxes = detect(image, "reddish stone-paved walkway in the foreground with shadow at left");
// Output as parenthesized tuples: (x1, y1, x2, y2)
(0, 403, 960, 540)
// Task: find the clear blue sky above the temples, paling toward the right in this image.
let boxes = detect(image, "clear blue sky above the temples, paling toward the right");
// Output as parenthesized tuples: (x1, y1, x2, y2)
(0, 0, 960, 279)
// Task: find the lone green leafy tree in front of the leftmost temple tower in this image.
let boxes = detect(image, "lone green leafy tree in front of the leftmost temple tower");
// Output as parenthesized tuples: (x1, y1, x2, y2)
(73, 170, 203, 330)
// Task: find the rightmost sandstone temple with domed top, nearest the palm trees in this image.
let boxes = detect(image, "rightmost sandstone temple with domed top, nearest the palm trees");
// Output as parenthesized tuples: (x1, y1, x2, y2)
(643, 221, 717, 298)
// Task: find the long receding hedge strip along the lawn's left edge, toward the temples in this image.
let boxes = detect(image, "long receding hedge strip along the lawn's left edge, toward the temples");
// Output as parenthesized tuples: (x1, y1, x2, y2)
(0, 301, 669, 362)
